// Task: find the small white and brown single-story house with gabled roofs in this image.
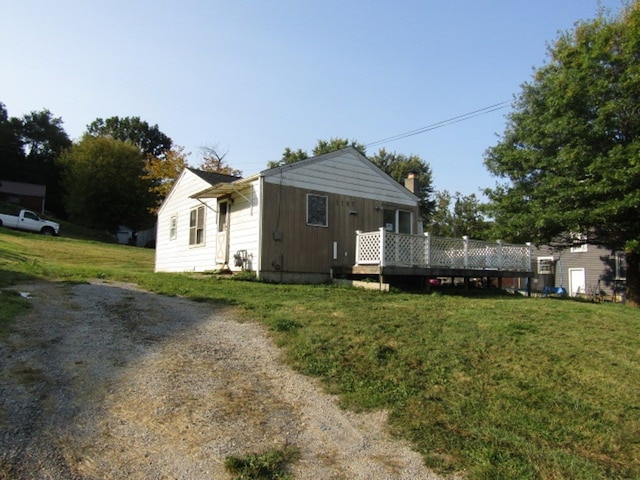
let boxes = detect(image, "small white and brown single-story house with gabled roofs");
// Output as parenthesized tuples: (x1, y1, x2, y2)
(156, 147, 422, 283)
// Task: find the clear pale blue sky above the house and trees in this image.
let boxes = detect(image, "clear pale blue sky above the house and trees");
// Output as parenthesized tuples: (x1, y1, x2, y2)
(0, 0, 622, 195)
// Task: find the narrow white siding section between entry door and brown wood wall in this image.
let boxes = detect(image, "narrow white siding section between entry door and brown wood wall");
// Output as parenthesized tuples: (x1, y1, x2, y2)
(229, 180, 262, 271)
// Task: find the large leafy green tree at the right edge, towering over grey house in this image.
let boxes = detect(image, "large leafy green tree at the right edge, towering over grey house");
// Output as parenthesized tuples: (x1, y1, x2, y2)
(485, 0, 640, 304)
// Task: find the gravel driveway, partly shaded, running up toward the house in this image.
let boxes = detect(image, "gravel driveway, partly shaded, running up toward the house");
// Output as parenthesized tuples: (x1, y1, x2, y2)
(0, 281, 438, 480)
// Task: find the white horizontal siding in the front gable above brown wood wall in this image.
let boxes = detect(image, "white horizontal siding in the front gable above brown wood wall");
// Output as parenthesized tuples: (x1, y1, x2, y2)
(265, 151, 416, 206)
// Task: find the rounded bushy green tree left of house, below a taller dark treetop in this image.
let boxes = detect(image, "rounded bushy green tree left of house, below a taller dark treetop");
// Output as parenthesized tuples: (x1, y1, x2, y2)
(59, 135, 154, 231)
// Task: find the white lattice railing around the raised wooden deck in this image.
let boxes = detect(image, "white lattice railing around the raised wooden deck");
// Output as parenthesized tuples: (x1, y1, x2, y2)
(356, 227, 531, 272)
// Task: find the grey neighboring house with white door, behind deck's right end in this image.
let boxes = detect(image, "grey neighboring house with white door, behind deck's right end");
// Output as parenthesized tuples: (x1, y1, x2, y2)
(532, 243, 626, 298)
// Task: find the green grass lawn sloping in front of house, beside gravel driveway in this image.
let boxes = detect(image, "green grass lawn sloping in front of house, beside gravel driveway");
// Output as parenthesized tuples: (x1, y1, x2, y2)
(0, 230, 640, 479)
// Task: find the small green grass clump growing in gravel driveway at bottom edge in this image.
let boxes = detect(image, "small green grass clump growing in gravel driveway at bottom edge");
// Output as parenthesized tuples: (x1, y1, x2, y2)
(224, 446, 300, 480)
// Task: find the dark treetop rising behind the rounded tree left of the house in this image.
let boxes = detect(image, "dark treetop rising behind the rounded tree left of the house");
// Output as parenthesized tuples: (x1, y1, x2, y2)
(87, 117, 173, 157)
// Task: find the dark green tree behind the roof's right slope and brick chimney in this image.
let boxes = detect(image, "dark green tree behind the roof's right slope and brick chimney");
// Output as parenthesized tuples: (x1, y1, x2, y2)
(369, 148, 434, 225)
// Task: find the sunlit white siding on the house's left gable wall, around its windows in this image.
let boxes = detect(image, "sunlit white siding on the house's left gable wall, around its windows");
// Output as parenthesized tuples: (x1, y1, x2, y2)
(155, 170, 217, 272)
